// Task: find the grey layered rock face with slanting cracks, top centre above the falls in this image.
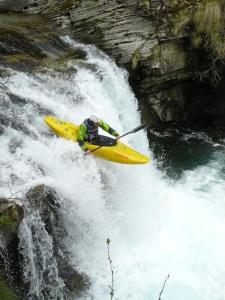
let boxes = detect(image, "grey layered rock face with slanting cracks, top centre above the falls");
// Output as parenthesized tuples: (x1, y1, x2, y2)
(70, 0, 157, 65)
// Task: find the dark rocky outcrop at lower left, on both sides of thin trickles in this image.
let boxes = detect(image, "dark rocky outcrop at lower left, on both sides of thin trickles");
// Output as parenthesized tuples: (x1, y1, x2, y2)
(0, 185, 90, 300)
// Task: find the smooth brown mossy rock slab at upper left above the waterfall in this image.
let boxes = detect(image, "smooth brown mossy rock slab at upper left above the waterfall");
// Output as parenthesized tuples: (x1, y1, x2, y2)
(0, 13, 85, 72)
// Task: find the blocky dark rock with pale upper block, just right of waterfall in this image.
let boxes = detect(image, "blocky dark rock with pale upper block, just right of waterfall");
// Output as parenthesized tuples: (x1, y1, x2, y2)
(130, 41, 192, 126)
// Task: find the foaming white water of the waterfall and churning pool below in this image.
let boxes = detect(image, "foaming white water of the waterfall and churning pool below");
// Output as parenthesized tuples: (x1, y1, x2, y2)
(0, 40, 225, 300)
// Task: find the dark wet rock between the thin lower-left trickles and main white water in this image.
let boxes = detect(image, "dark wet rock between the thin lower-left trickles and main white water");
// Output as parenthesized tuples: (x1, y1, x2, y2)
(27, 185, 89, 299)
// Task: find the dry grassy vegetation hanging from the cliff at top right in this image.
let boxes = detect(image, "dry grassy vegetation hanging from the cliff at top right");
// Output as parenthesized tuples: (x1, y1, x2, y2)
(173, 0, 225, 85)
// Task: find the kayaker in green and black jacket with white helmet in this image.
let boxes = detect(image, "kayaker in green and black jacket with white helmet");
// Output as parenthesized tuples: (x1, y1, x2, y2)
(77, 115, 120, 154)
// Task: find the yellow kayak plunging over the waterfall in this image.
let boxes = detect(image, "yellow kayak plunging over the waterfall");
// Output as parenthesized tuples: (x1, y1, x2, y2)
(44, 116, 150, 164)
